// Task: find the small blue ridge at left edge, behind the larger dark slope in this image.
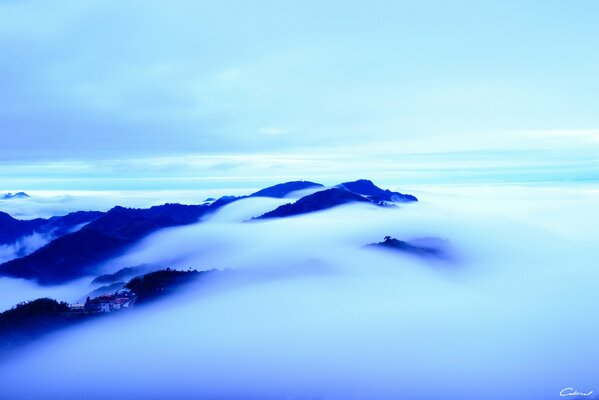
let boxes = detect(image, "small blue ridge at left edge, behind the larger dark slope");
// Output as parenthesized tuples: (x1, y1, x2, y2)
(0, 211, 103, 245)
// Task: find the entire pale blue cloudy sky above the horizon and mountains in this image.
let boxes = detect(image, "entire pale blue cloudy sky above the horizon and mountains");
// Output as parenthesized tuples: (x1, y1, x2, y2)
(0, 0, 599, 191)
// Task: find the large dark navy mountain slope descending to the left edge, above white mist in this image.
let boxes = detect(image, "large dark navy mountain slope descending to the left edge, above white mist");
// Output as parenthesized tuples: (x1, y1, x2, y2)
(0, 204, 211, 284)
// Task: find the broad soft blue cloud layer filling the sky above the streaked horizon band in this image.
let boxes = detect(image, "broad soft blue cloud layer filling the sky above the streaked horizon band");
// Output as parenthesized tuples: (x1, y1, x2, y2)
(0, 1, 599, 167)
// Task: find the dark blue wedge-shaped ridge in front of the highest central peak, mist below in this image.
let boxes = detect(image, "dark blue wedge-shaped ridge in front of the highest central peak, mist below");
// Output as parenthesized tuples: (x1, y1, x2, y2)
(256, 188, 372, 219)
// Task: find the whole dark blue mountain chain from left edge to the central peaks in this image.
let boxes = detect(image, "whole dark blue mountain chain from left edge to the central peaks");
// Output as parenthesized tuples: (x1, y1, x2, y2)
(0, 180, 417, 284)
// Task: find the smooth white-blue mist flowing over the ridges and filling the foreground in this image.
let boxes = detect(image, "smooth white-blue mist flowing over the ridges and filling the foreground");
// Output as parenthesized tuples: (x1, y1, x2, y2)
(0, 186, 599, 400)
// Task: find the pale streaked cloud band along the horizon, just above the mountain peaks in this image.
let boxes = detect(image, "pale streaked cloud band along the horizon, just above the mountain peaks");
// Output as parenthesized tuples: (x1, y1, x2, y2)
(2, 138, 599, 192)
